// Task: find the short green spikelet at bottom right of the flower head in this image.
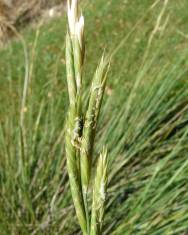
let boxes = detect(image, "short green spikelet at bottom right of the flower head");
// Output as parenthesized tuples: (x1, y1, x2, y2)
(90, 149, 108, 235)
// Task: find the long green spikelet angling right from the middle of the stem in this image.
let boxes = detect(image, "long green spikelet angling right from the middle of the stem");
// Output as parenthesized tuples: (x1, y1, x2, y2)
(80, 57, 109, 194)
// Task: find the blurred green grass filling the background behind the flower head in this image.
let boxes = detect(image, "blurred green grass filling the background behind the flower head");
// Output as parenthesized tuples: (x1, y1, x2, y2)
(0, 0, 188, 235)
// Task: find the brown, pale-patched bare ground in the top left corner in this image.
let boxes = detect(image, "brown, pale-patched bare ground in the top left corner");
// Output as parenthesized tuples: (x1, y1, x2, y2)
(0, 0, 66, 47)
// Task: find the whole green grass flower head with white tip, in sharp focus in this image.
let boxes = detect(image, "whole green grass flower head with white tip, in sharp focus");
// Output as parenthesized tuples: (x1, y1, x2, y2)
(65, 0, 109, 235)
